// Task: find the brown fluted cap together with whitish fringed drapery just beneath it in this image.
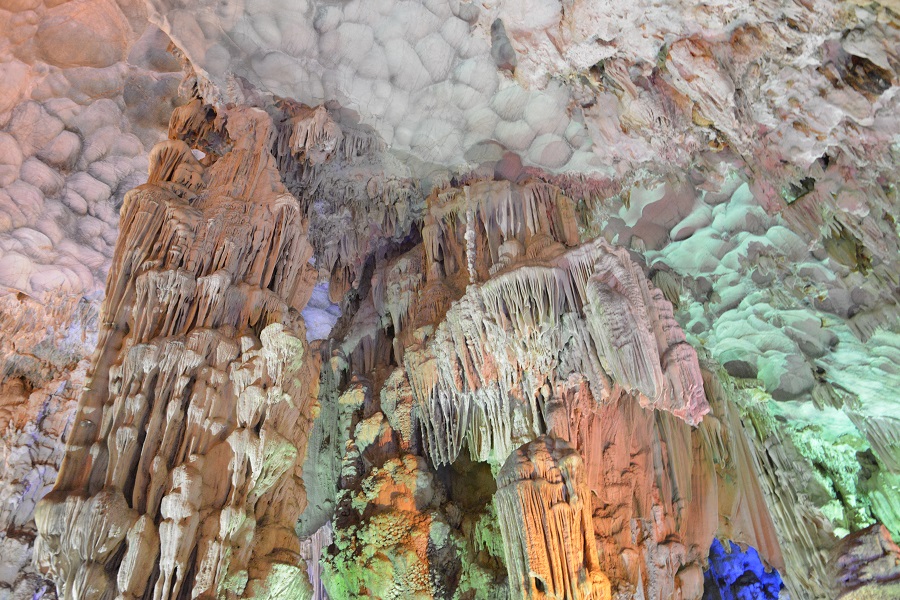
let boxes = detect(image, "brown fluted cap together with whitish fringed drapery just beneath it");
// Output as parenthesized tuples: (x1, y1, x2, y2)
(404, 182, 708, 466)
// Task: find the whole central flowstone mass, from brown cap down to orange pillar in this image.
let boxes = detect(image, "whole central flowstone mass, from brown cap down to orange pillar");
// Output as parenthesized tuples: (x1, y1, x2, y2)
(309, 176, 732, 598)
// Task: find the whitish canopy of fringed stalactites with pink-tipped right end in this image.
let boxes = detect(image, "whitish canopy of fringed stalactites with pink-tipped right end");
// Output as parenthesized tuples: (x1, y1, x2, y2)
(404, 236, 709, 463)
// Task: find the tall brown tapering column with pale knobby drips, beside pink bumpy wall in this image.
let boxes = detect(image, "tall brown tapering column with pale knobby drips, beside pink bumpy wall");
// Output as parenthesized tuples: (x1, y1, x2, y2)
(36, 109, 317, 598)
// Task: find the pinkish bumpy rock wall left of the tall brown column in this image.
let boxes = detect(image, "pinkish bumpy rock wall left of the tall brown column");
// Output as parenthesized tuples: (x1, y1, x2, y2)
(0, 0, 182, 597)
